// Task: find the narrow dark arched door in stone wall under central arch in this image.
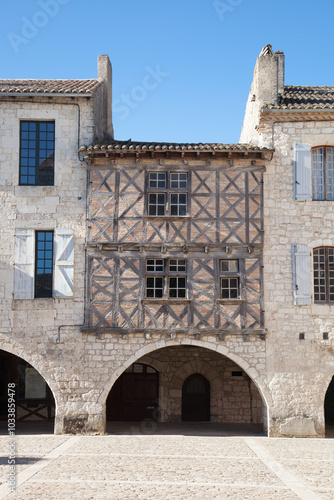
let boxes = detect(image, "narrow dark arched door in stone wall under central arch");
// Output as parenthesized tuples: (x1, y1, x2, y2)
(182, 373, 210, 422)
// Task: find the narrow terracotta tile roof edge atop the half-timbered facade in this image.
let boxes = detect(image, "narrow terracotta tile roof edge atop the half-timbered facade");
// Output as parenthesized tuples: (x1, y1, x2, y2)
(80, 140, 271, 153)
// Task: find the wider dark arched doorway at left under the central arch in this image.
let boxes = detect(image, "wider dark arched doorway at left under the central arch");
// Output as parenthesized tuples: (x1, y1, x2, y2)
(107, 363, 159, 422)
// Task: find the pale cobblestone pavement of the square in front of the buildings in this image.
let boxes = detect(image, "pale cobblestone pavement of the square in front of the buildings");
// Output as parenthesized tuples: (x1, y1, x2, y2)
(0, 431, 334, 500)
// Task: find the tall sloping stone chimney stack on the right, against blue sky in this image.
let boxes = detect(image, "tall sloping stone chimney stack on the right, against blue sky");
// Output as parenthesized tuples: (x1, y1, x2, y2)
(240, 44, 284, 145)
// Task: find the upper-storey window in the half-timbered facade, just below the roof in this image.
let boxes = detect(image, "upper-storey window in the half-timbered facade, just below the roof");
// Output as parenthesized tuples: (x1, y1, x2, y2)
(148, 172, 188, 217)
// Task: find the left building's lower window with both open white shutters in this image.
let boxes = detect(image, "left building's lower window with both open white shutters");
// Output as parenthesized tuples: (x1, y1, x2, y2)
(14, 228, 74, 299)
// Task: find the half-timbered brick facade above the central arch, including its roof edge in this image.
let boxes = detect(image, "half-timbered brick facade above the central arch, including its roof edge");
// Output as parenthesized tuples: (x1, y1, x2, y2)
(83, 142, 271, 338)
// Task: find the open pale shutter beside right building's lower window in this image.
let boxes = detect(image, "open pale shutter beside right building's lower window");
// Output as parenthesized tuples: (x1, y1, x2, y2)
(292, 245, 311, 306)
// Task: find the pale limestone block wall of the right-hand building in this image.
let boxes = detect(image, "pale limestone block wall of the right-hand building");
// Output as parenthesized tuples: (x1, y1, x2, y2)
(261, 121, 334, 436)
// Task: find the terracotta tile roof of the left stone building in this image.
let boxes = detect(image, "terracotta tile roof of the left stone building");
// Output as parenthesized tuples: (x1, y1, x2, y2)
(0, 80, 100, 95)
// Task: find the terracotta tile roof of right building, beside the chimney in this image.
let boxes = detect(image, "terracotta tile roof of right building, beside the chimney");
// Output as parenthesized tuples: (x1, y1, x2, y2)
(265, 85, 334, 109)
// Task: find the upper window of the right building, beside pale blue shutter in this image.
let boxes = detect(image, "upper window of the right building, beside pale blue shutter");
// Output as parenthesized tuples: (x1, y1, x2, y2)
(312, 147, 334, 200)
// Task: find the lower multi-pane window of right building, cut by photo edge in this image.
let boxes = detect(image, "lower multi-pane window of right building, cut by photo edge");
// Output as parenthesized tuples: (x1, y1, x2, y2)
(313, 247, 334, 302)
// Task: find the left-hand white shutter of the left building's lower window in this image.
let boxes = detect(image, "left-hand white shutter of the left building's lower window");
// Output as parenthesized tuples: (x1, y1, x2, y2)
(14, 229, 35, 299)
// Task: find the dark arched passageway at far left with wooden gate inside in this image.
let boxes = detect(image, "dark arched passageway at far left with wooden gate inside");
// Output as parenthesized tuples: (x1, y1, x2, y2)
(0, 350, 55, 424)
